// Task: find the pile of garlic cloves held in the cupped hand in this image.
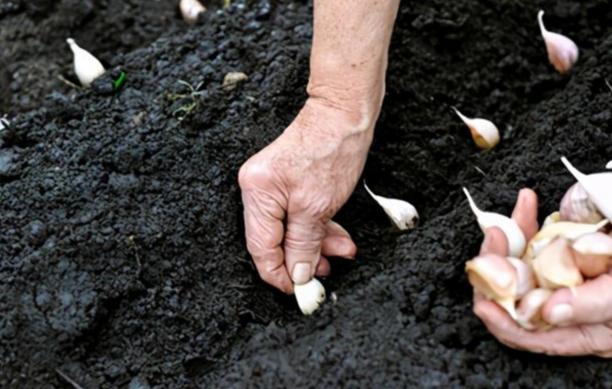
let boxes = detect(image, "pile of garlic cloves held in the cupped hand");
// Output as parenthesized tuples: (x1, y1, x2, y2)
(464, 157, 612, 330)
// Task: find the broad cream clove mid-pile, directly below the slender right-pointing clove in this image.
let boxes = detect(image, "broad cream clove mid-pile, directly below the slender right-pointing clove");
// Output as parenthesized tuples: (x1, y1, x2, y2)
(531, 238, 584, 290)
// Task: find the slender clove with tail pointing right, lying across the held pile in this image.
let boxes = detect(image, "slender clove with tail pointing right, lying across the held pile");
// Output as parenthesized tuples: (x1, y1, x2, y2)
(522, 219, 608, 262)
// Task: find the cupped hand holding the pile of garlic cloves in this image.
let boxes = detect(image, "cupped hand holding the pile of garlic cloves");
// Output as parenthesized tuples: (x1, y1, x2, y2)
(474, 189, 612, 357)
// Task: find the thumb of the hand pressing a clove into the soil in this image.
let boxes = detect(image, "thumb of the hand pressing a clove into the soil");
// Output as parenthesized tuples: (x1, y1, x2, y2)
(284, 215, 325, 285)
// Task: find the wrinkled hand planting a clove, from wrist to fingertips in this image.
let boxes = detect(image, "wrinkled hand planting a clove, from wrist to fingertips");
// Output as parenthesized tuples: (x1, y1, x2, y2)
(239, 98, 374, 293)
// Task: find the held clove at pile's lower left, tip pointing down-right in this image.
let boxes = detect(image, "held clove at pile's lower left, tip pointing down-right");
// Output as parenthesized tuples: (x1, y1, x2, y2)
(465, 255, 518, 319)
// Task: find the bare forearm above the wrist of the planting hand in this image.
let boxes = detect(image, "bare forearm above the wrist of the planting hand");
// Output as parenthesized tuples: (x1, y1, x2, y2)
(308, 0, 399, 127)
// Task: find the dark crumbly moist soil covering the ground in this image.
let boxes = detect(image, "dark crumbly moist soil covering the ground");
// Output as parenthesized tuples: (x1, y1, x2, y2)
(0, 0, 612, 389)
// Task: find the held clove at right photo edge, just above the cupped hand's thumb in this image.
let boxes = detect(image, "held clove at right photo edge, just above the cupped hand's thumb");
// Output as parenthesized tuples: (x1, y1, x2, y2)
(572, 232, 612, 277)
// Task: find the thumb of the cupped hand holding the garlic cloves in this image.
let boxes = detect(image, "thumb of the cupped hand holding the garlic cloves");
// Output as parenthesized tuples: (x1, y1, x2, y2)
(542, 274, 612, 326)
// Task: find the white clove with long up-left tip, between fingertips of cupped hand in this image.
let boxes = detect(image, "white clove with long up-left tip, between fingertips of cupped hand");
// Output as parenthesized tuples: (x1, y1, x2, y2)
(463, 188, 526, 258)
